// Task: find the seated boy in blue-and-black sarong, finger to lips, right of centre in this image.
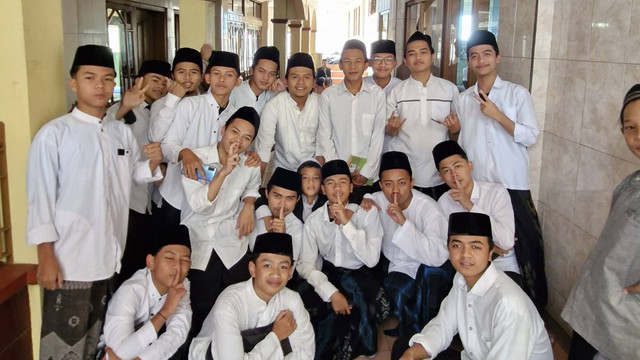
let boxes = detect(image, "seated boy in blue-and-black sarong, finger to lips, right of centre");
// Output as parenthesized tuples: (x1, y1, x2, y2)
(361, 151, 453, 336)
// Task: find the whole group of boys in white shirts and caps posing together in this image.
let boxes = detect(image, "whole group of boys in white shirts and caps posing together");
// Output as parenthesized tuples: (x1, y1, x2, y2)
(27, 31, 551, 359)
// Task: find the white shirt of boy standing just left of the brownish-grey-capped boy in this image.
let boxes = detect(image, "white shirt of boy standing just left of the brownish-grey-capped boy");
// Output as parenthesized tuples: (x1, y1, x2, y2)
(255, 92, 319, 171)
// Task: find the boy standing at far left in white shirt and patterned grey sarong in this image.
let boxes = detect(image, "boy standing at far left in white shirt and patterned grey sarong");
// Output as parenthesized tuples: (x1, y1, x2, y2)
(26, 45, 162, 359)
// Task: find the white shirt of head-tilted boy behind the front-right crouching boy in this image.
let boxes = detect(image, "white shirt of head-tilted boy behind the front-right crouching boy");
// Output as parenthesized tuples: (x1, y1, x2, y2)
(438, 180, 520, 274)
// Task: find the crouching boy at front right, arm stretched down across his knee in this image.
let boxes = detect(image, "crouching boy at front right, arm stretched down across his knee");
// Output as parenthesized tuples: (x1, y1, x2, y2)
(392, 212, 553, 360)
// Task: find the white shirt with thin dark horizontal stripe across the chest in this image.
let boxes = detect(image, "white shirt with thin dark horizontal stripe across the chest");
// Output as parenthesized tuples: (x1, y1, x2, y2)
(385, 74, 458, 187)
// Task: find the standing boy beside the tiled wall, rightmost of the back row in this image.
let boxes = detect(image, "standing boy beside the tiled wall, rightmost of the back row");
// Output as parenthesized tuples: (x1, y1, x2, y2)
(459, 30, 547, 306)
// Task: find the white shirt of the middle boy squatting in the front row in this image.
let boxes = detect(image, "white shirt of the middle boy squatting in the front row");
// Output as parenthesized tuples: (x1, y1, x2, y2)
(189, 279, 316, 360)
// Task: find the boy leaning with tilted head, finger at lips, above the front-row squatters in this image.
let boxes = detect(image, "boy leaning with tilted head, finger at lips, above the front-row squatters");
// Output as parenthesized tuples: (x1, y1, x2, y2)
(182, 106, 260, 342)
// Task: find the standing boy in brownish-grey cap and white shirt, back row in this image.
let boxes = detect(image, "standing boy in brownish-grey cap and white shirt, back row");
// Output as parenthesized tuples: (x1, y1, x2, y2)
(316, 40, 385, 203)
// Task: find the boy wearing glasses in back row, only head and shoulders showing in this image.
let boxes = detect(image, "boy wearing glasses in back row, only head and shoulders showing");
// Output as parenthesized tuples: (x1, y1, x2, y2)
(364, 40, 402, 95)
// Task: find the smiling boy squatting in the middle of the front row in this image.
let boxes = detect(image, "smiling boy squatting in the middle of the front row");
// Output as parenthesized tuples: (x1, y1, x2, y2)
(189, 233, 315, 360)
